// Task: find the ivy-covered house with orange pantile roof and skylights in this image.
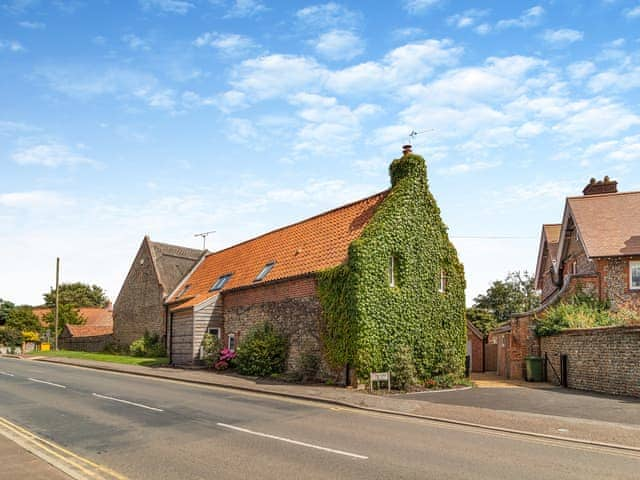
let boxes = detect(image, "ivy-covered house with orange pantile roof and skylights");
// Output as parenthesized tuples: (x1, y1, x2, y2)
(167, 148, 466, 382)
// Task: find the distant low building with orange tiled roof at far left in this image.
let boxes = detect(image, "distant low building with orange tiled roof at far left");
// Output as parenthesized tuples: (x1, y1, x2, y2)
(33, 304, 113, 352)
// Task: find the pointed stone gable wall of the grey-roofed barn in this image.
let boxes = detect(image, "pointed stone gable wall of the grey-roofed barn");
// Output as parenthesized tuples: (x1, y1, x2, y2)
(113, 241, 166, 346)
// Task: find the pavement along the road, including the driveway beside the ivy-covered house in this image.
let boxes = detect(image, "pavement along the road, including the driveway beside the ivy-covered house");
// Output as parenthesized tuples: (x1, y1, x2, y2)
(20, 357, 640, 448)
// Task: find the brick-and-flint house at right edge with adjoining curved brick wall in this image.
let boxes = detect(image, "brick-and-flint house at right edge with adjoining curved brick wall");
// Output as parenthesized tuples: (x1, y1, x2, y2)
(490, 177, 640, 378)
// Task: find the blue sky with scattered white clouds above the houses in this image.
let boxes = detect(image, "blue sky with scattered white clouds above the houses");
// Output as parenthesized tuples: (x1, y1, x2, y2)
(0, 0, 640, 304)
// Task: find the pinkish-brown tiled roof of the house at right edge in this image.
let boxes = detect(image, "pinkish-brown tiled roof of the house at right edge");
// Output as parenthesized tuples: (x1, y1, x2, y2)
(567, 192, 640, 257)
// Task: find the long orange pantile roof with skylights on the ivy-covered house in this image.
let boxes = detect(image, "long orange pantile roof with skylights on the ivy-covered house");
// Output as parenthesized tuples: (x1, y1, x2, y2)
(168, 190, 388, 310)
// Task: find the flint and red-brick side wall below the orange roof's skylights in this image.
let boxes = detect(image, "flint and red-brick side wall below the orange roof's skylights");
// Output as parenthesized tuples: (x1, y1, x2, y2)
(223, 277, 326, 370)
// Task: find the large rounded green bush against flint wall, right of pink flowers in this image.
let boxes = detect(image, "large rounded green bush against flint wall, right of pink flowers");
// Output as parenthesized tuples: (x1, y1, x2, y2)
(237, 323, 288, 377)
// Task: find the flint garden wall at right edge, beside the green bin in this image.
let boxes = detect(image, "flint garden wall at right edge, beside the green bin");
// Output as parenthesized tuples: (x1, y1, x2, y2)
(540, 327, 640, 397)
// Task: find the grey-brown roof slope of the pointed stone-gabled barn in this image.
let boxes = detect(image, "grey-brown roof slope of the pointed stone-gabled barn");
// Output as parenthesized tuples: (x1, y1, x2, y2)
(146, 237, 205, 294)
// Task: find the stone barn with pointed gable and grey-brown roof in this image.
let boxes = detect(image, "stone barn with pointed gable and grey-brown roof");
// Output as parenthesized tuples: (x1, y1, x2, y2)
(113, 236, 206, 347)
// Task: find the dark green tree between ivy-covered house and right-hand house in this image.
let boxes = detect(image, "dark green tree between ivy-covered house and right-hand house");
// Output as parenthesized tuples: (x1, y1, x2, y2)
(473, 271, 540, 323)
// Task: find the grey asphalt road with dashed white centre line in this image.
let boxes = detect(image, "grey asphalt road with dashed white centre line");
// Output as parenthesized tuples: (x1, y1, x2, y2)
(0, 358, 640, 480)
